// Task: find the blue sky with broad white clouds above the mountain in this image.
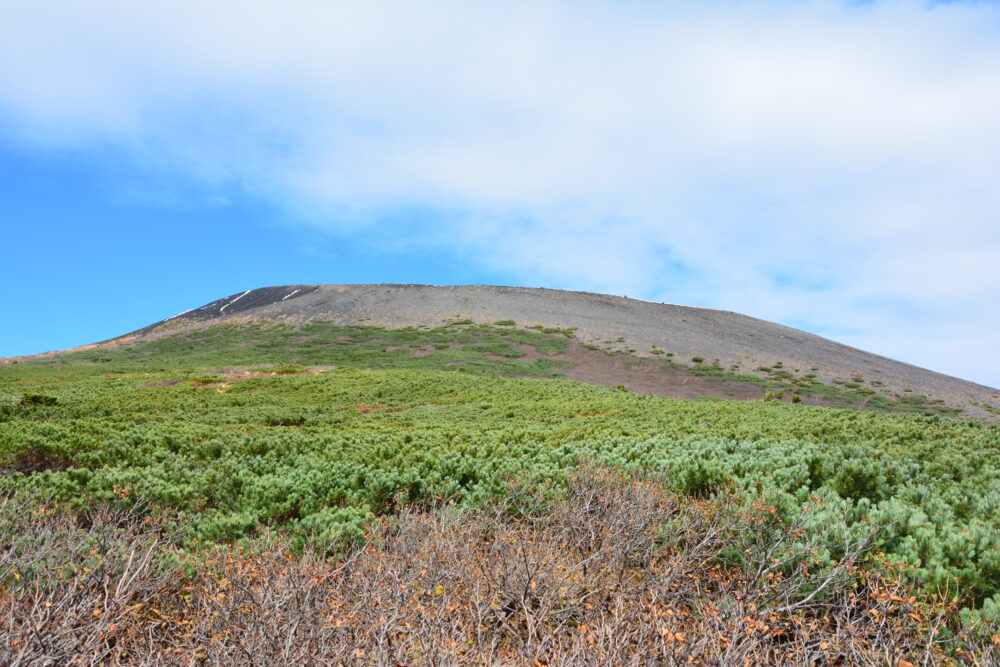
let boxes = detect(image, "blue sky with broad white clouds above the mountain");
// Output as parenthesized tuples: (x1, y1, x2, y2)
(0, 0, 1000, 386)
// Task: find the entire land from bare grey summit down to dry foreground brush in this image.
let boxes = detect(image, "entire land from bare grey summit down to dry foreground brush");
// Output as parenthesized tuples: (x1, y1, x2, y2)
(0, 285, 1000, 665)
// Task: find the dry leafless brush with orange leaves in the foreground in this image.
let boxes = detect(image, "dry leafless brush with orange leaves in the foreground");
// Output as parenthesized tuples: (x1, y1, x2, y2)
(0, 471, 998, 667)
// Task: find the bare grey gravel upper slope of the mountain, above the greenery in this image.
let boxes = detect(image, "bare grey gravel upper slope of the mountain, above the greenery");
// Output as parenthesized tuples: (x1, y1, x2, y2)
(123, 284, 1000, 416)
